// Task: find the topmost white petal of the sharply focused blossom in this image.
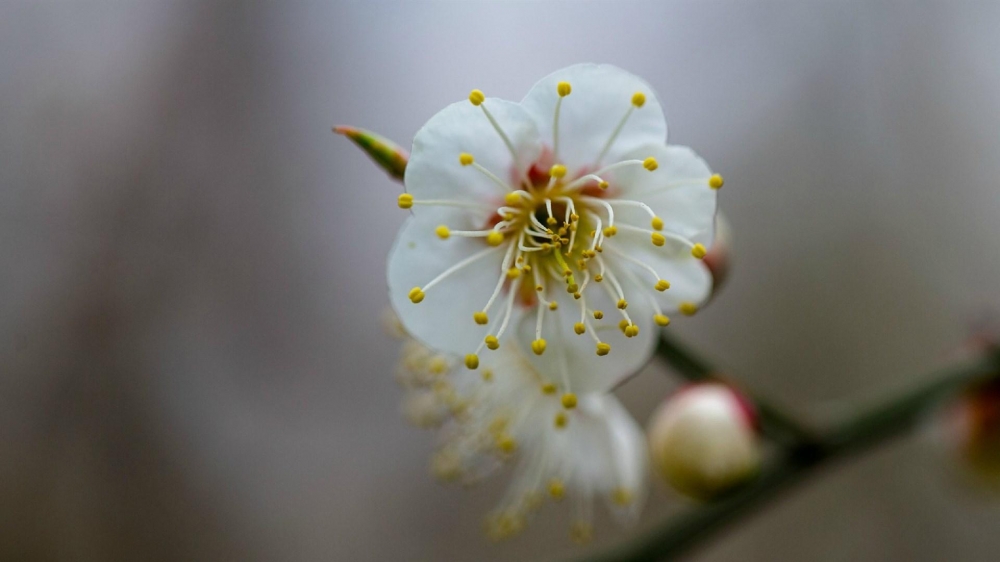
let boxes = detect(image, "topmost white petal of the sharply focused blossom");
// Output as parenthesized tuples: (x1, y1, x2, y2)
(521, 64, 667, 176)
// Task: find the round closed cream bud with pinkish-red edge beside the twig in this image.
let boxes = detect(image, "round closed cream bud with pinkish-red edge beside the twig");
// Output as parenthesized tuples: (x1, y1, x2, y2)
(647, 383, 760, 500)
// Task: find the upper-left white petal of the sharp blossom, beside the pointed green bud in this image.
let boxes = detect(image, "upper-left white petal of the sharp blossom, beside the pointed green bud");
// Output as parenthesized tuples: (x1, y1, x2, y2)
(404, 98, 541, 224)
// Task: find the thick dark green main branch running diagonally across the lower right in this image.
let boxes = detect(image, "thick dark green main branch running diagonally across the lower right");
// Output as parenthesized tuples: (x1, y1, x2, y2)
(587, 344, 1000, 562)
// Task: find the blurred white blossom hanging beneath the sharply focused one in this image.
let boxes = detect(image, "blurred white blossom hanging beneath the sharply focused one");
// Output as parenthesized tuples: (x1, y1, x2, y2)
(397, 312, 648, 542)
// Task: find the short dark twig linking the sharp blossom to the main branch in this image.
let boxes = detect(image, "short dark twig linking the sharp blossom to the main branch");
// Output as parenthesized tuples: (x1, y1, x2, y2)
(656, 333, 819, 444)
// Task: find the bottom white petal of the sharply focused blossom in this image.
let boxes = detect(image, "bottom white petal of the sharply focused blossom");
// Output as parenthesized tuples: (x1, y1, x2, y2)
(517, 266, 657, 394)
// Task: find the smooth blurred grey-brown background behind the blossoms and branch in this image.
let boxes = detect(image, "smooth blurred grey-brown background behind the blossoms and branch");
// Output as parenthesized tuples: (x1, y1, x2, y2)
(0, 0, 1000, 562)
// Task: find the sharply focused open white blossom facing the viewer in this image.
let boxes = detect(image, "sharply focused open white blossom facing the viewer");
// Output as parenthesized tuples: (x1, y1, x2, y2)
(388, 64, 722, 393)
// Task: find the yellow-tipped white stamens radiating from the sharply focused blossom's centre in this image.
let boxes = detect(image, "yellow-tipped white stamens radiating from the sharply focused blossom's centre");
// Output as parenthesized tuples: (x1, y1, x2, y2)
(398, 82, 723, 396)
